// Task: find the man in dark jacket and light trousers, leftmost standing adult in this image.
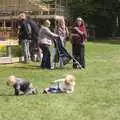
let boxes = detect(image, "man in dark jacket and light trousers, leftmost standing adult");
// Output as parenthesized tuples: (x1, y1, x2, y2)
(19, 13, 31, 63)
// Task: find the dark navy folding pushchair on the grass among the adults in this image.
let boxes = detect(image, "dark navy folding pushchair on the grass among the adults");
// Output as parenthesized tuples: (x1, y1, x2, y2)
(54, 38, 82, 69)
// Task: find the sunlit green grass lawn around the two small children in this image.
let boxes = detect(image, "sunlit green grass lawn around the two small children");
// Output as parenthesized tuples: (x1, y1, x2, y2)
(0, 41, 120, 120)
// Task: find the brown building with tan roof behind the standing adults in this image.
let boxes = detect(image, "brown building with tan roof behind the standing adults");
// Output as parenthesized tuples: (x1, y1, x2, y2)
(0, 0, 67, 36)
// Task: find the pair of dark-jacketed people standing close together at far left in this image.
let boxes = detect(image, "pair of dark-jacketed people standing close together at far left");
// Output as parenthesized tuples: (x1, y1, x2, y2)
(18, 13, 40, 63)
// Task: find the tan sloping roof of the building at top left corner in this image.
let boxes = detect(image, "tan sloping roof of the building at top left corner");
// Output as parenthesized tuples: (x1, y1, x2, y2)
(0, 0, 47, 12)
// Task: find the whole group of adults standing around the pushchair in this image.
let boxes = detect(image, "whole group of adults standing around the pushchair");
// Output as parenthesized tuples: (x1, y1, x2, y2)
(19, 13, 87, 69)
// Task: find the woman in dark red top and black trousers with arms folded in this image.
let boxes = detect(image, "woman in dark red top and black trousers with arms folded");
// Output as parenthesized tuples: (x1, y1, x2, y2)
(71, 18, 87, 68)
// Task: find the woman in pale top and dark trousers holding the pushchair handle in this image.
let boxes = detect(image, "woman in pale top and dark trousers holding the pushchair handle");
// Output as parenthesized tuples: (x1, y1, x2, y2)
(38, 20, 59, 69)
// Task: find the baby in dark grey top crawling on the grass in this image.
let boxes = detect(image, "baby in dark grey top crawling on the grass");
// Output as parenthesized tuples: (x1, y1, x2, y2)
(7, 75, 37, 95)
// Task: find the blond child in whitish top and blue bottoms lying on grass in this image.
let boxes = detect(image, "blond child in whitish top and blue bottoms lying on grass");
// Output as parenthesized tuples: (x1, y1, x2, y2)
(43, 75, 76, 94)
